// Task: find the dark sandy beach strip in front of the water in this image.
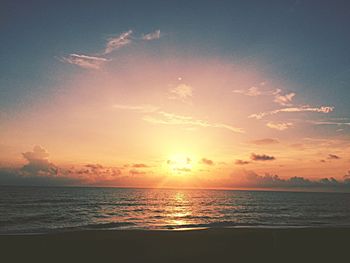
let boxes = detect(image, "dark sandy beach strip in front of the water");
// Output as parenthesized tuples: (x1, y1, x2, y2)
(0, 228, 350, 263)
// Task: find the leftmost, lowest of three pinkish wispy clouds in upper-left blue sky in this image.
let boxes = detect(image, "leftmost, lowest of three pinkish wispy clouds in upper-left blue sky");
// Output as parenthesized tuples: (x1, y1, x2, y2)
(60, 54, 109, 69)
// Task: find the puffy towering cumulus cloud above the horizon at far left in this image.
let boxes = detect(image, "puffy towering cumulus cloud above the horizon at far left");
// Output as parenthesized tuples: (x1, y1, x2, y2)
(21, 145, 58, 176)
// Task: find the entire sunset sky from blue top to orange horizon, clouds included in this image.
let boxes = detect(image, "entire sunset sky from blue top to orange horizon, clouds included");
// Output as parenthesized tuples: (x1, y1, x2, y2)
(0, 0, 350, 191)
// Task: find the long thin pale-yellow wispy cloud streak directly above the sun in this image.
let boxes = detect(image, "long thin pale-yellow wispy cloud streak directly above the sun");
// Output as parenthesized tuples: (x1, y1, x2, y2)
(143, 111, 244, 133)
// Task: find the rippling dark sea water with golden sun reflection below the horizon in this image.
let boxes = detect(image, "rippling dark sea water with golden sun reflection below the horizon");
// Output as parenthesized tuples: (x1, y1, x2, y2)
(0, 186, 350, 234)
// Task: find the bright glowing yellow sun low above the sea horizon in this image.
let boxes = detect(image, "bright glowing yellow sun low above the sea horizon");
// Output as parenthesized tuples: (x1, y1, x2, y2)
(166, 154, 194, 175)
